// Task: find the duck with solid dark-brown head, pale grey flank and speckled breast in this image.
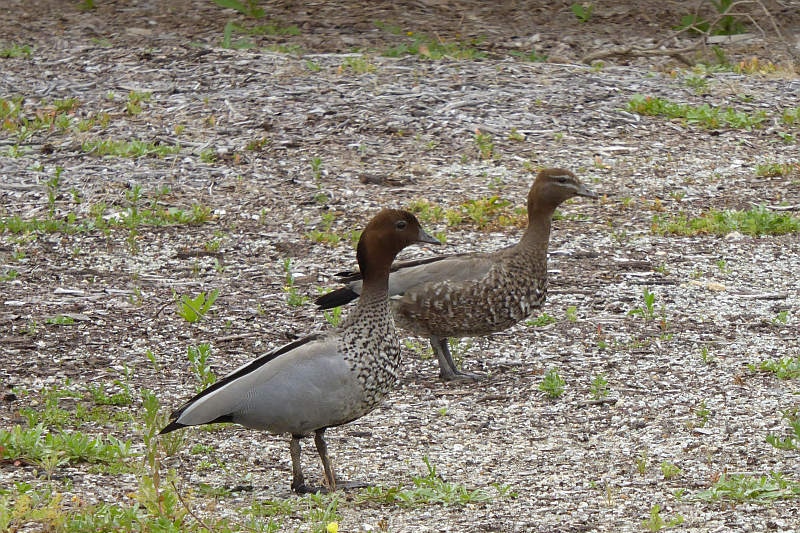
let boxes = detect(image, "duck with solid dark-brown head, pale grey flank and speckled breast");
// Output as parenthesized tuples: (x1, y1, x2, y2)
(161, 209, 439, 492)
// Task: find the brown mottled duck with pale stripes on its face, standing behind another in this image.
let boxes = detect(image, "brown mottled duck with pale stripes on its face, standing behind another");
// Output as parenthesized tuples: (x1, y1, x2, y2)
(316, 168, 597, 381)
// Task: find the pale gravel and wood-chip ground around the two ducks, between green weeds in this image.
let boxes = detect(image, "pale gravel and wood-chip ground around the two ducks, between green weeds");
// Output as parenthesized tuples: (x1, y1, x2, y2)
(0, 1, 800, 532)
